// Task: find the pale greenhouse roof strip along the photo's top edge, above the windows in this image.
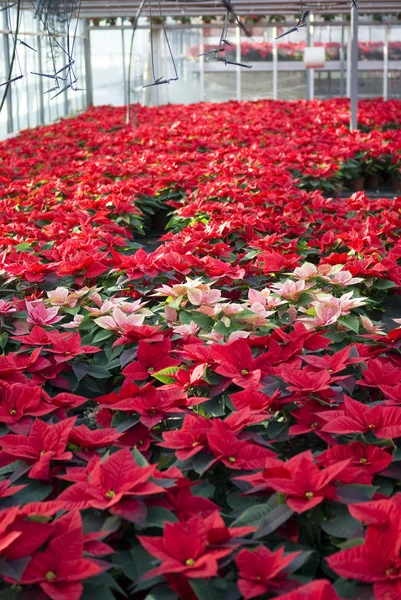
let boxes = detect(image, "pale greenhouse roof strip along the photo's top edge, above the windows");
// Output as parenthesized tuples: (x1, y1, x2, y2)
(0, 0, 401, 17)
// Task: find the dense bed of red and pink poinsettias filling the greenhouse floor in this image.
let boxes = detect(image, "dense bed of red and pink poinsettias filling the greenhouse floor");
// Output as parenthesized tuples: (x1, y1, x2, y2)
(0, 100, 401, 600)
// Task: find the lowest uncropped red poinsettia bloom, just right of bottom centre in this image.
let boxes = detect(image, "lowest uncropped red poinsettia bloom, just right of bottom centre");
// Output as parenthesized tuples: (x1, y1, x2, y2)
(235, 546, 300, 600)
